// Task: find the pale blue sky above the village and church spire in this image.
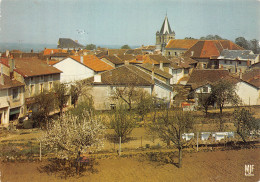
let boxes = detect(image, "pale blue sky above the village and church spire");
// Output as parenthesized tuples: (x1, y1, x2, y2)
(0, 0, 260, 45)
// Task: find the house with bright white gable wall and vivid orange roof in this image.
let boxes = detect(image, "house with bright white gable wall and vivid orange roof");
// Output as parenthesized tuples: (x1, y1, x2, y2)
(53, 55, 114, 83)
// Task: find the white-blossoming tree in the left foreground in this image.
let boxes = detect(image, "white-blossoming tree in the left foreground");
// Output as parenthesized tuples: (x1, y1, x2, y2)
(42, 111, 105, 173)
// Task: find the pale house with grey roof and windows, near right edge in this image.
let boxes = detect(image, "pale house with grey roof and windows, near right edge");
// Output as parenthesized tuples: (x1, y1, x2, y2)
(214, 50, 259, 73)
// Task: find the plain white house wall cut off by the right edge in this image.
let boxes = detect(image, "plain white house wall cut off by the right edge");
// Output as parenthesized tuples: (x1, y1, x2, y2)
(236, 82, 260, 105)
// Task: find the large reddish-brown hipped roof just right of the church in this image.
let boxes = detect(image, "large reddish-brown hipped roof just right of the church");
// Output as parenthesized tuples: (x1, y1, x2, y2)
(184, 40, 243, 58)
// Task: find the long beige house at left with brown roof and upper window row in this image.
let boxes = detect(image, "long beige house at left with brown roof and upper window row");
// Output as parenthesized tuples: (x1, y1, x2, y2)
(0, 58, 61, 114)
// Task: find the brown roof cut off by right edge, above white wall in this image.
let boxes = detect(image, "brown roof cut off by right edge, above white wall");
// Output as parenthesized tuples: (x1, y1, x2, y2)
(242, 68, 260, 88)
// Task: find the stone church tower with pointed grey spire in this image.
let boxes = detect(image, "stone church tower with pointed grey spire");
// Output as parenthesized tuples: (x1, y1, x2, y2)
(156, 15, 175, 51)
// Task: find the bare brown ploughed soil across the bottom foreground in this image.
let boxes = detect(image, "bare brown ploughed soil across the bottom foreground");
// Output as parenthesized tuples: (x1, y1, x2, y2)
(0, 149, 260, 182)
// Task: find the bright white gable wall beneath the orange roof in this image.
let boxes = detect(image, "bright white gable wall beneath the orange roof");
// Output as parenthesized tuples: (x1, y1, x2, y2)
(53, 58, 94, 83)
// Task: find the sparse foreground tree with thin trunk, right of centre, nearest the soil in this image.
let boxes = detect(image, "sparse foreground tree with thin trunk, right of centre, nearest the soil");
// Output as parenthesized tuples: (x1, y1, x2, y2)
(150, 109, 194, 168)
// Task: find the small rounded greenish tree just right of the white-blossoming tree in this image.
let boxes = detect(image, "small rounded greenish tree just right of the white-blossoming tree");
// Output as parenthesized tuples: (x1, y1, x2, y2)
(110, 107, 136, 142)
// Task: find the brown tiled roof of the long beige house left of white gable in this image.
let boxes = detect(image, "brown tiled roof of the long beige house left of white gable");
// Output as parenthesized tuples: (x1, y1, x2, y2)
(1, 58, 62, 77)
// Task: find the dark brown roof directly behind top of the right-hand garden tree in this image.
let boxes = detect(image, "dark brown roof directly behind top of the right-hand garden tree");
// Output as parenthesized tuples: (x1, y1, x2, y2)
(187, 69, 230, 89)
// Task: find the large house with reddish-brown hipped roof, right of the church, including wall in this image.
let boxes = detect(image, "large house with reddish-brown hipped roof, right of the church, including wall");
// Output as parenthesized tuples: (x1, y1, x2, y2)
(184, 40, 243, 69)
